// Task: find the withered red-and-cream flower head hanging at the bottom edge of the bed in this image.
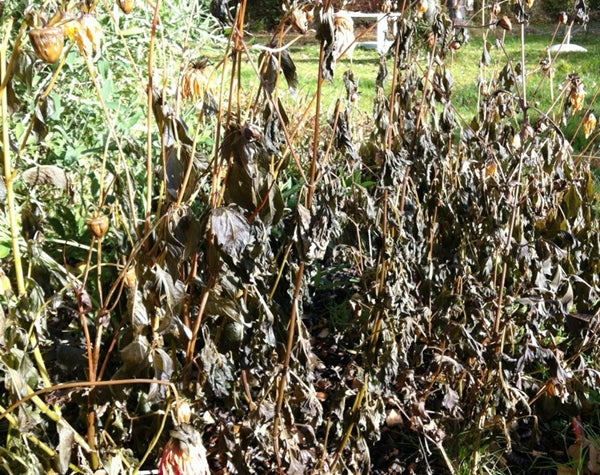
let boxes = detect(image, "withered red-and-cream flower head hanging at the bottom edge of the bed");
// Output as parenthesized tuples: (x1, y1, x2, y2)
(158, 424, 210, 475)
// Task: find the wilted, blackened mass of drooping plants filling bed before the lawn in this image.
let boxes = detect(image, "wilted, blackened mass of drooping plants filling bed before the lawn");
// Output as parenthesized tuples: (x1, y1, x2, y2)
(0, 1, 600, 474)
